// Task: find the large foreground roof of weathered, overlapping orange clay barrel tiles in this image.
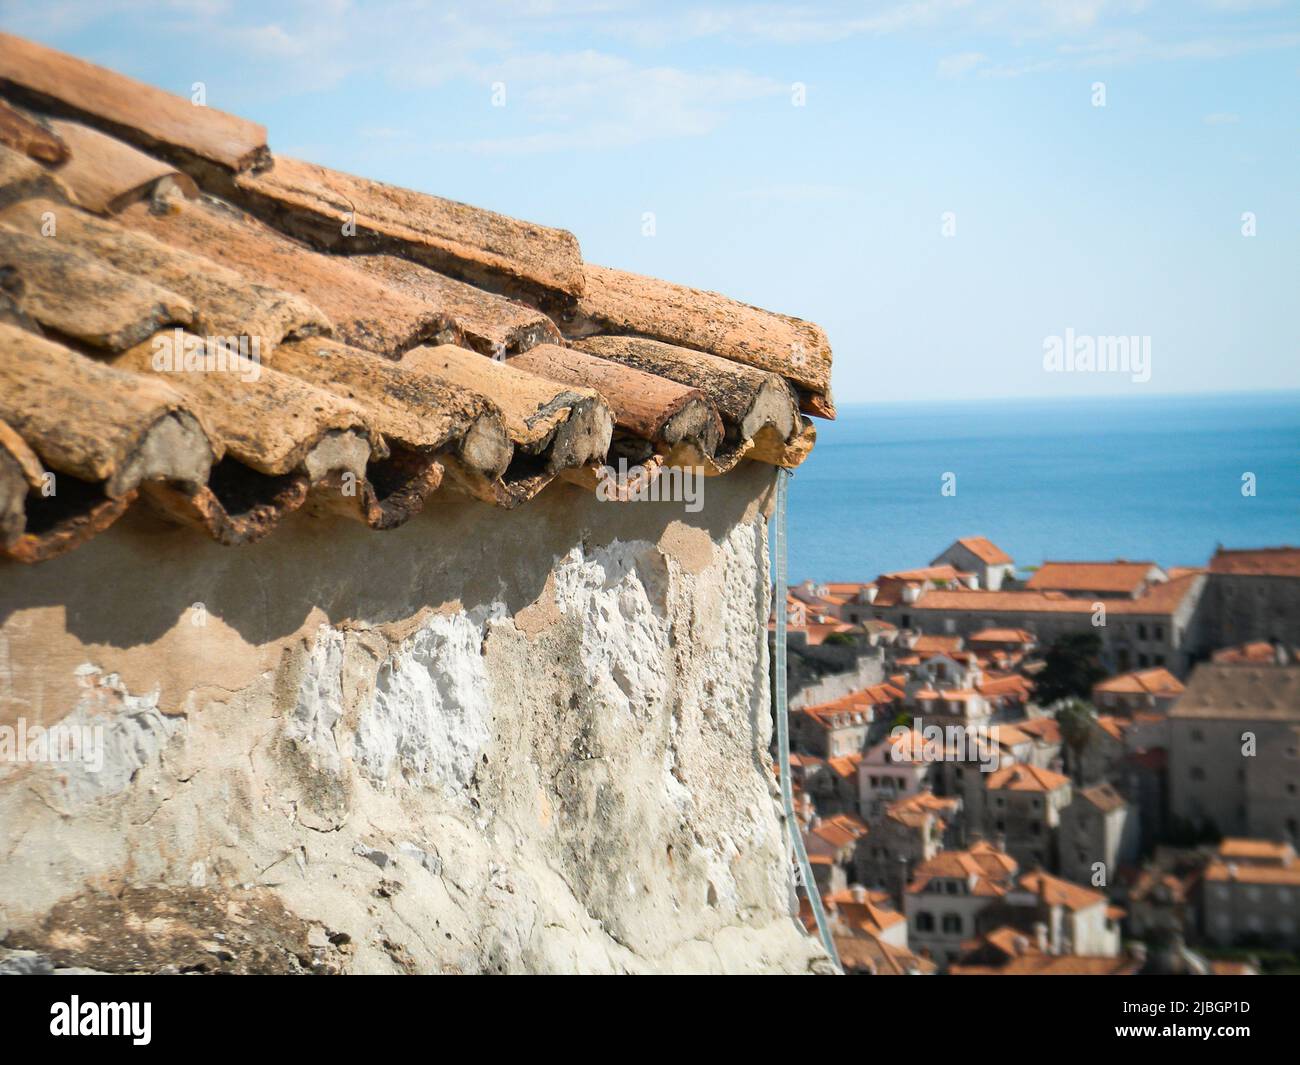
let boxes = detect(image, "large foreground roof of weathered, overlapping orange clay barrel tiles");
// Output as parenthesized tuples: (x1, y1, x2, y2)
(0, 35, 833, 562)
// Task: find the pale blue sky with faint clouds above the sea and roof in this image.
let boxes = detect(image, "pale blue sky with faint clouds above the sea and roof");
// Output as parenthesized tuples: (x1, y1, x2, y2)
(10, 0, 1300, 403)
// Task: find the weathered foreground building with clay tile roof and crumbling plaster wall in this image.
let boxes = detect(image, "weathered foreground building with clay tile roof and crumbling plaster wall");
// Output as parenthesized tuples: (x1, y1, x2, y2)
(0, 36, 833, 973)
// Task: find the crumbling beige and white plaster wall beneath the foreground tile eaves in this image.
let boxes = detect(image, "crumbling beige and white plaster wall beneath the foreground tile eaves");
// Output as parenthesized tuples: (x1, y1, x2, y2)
(0, 464, 822, 973)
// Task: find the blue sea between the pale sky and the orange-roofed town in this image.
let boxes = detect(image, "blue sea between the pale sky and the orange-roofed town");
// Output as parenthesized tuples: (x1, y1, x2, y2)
(789, 393, 1300, 581)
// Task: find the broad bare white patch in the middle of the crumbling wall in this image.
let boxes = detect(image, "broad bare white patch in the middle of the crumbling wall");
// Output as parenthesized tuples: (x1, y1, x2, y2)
(355, 614, 490, 792)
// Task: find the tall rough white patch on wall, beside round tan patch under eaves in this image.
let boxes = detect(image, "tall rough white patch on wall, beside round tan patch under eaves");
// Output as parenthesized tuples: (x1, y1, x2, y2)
(555, 540, 670, 719)
